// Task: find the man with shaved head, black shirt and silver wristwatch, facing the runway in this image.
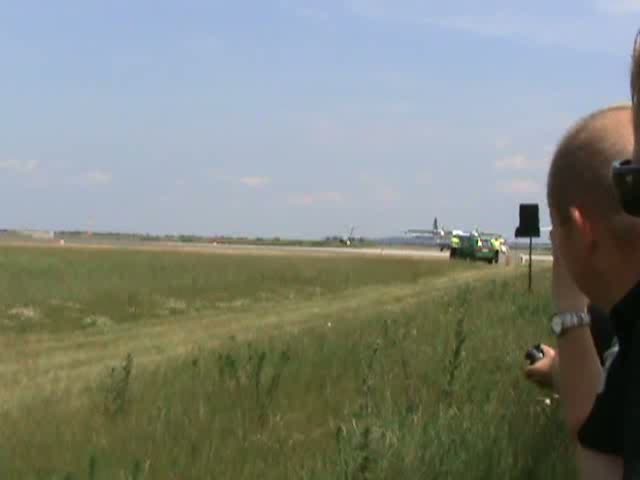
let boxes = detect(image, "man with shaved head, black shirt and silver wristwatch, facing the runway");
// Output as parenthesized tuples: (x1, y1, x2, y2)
(547, 100, 640, 480)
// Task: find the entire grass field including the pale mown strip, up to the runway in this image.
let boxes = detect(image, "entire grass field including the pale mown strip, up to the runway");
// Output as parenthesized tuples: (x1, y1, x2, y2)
(0, 247, 575, 480)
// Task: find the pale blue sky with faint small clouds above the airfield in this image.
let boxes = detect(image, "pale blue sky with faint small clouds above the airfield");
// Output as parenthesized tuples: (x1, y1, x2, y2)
(0, 0, 640, 237)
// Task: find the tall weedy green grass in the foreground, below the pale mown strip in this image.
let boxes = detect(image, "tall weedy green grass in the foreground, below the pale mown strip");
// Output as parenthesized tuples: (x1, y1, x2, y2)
(0, 259, 575, 480)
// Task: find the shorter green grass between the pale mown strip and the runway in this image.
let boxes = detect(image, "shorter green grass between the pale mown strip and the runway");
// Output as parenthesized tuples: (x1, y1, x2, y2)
(0, 246, 460, 332)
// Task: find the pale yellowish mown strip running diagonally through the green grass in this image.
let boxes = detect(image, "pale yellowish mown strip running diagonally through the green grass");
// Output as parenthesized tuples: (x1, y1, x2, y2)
(0, 268, 518, 409)
